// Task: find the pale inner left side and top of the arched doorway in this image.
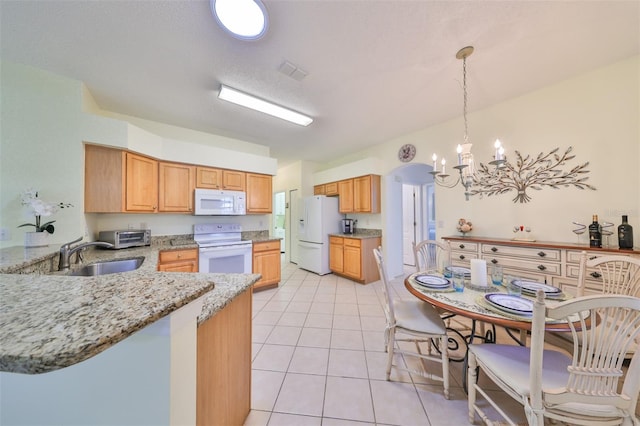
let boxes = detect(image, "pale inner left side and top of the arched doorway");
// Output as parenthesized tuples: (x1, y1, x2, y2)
(382, 163, 433, 277)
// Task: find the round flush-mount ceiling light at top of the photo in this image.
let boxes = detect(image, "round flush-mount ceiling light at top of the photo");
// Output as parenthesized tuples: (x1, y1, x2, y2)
(211, 0, 268, 40)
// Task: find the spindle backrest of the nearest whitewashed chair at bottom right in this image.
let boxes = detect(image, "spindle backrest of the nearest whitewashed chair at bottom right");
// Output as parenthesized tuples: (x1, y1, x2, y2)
(530, 291, 640, 412)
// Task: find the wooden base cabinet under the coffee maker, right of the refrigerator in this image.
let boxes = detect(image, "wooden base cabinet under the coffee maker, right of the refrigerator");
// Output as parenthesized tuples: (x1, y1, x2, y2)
(329, 236, 381, 284)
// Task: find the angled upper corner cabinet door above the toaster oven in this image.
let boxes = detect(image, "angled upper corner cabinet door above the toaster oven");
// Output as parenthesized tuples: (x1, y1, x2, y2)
(125, 152, 158, 212)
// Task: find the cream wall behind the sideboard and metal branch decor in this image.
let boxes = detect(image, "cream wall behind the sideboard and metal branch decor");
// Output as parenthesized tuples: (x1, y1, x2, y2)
(308, 57, 640, 275)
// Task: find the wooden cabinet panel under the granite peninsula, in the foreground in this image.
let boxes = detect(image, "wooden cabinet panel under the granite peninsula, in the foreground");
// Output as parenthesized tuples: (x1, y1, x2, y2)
(196, 289, 252, 426)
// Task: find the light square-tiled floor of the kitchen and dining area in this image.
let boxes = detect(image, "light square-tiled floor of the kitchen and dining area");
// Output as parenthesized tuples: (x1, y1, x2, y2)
(245, 263, 640, 426)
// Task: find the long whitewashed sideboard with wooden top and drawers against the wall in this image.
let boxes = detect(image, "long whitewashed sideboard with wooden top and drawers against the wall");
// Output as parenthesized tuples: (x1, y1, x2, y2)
(442, 236, 640, 294)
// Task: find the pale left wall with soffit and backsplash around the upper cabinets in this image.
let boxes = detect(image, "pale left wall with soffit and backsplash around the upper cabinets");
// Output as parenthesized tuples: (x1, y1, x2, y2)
(0, 61, 277, 248)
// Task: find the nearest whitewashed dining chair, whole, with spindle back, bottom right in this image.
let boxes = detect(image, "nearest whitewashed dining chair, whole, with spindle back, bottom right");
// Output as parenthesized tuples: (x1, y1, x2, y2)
(467, 290, 640, 426)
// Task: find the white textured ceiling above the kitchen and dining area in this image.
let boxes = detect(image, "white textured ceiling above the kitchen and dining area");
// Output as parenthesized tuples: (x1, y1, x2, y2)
(0, 0, 640, 164)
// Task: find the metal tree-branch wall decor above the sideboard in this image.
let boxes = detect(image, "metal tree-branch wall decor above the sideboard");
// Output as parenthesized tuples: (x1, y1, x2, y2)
(469, 147, 596, 203)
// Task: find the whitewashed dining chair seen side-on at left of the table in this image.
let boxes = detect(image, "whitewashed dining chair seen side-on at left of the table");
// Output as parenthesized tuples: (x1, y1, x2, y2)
(373, 247, 449, 399)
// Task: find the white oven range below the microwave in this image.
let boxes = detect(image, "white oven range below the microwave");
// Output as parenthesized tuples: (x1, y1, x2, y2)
(193, 223, 253, 274)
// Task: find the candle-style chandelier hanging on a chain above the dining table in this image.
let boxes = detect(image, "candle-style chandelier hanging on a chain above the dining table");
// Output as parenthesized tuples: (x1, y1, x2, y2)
(429, 46, 506, 201)
